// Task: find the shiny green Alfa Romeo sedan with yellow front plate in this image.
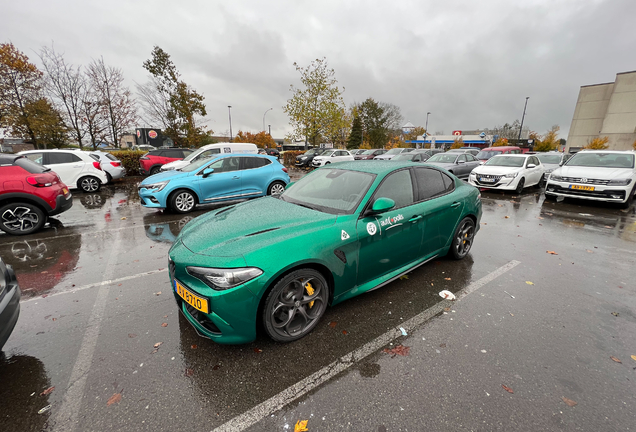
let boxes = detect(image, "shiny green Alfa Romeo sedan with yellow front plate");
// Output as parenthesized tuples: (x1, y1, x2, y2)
(169, 161, 481, 344)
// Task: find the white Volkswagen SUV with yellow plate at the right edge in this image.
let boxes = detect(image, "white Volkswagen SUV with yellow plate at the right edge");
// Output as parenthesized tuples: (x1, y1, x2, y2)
(545, 150, 636, 207)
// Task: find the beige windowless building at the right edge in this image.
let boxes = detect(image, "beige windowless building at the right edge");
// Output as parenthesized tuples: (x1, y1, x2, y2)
(565, 71, 636, 151)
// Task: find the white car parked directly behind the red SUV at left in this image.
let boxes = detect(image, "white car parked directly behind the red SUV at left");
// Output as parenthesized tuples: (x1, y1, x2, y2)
(18, 149, 108, 192)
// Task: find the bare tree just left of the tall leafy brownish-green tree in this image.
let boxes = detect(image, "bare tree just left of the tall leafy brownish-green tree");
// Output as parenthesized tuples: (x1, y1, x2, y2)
(87, 58, 138, 147)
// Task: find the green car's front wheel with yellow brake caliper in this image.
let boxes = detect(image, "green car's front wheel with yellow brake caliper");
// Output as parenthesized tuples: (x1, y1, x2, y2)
(262, 268, 329, 342)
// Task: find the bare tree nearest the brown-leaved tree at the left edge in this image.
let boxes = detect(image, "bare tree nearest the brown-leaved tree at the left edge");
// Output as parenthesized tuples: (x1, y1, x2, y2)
(39, 47, 87, 148)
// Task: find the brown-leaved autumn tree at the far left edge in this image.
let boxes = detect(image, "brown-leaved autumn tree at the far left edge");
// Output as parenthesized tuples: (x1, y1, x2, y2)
(0, 43, 42, 147)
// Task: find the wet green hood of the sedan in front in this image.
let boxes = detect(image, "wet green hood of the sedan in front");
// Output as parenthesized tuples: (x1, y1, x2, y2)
(179, 197, 337, 257)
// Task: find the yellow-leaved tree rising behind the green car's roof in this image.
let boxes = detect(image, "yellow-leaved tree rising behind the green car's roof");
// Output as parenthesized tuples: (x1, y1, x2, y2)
(283, 58, 347, 146)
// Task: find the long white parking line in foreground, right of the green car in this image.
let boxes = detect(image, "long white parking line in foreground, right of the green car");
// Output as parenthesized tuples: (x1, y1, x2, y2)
(212, 261, 520, 432)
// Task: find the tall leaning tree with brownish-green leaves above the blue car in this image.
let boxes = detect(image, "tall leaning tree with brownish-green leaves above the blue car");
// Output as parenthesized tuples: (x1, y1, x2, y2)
(137, 46, 211, 147)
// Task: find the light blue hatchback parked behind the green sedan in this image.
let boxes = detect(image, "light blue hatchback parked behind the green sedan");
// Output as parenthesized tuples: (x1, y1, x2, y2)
(139, 153, 289, 213)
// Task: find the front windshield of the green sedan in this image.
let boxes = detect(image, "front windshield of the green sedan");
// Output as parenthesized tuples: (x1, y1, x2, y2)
(280, 168, 375, 214)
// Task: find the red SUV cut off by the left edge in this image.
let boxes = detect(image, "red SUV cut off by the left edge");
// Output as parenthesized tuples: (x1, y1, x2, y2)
(0, 154, 73, 235)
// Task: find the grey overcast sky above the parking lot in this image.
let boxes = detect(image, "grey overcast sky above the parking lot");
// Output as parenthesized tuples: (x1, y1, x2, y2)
(0, 0, 636, 138)
